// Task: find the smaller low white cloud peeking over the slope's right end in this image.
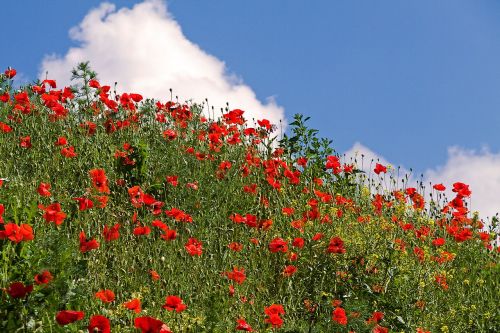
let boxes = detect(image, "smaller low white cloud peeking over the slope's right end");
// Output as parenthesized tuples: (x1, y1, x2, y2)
(344, 142, 500, 218)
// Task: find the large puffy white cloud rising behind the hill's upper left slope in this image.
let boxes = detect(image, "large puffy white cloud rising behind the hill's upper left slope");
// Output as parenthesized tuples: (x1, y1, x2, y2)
(40, 0, 285, 124)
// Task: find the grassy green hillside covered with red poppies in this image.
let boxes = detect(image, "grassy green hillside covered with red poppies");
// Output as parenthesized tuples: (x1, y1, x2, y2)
(0, 63, 500, 333)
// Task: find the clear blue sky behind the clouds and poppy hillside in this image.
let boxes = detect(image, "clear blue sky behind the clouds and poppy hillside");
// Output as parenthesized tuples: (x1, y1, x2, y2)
(0, 0, 500, 215)
